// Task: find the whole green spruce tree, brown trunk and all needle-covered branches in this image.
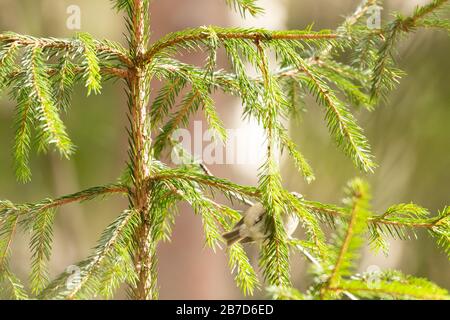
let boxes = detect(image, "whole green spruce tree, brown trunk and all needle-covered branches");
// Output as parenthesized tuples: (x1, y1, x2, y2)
(0, 0, 450, 299)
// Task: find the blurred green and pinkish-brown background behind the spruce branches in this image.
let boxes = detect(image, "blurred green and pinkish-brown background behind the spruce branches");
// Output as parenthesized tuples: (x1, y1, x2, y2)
(0, 0, 450, 299)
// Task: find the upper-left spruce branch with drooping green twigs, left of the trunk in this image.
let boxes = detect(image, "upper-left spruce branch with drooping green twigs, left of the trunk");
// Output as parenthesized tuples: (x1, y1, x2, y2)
(0, 32, 126, 182)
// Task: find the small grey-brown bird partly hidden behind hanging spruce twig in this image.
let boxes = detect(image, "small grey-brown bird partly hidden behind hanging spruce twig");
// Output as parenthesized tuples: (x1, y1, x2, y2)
(222, 192, 303, 246)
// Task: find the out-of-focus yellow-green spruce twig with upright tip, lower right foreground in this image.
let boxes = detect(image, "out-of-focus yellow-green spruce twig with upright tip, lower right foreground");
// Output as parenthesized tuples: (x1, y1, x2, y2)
(268, 179, 450, 300)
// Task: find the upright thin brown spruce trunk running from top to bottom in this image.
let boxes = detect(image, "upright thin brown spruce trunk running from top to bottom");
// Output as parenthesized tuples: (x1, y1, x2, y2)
(128, 0, 156, 300)
